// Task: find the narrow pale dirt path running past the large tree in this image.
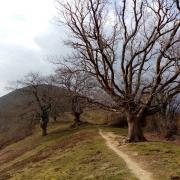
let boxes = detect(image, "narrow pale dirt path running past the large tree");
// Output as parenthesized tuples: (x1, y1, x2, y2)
(99, 129, 153, 180)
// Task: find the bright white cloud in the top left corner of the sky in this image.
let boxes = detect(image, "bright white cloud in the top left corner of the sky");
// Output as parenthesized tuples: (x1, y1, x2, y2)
(0, 0, 55, 50)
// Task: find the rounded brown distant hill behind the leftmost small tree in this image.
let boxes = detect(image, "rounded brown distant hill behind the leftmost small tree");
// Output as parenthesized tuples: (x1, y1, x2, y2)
(0, 85, 70, 148)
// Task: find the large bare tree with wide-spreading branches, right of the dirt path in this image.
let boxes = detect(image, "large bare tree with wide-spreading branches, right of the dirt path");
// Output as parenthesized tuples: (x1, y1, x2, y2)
(57, 0, 180, 142)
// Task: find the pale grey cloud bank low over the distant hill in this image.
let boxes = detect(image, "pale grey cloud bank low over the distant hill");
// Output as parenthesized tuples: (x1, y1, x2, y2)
(0, 44, 53, 96)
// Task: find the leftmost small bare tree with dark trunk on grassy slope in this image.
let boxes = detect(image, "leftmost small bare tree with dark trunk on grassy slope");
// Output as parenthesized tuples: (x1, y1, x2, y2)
(16, 73, 63, 136)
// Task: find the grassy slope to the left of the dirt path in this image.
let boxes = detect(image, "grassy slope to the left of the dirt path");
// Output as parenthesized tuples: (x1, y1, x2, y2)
(0, 123, 136, 180)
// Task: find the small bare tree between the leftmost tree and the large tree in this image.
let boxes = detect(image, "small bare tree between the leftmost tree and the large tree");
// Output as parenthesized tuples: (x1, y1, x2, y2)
(55, 64, 98, 127)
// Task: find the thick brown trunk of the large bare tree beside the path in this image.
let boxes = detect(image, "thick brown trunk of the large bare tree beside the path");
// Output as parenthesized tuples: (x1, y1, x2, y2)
(127, 114, 146, 142)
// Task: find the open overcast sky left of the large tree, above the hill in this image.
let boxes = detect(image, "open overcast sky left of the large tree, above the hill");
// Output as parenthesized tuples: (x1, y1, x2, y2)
(0, 0, 66, 96)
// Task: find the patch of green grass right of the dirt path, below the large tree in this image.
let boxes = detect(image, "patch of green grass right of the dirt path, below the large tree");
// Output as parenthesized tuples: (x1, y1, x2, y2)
(128, 141, 180, 180)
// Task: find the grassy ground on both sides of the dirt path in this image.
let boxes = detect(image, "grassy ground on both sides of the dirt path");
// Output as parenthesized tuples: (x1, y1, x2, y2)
(0, 122, 180, 180)
